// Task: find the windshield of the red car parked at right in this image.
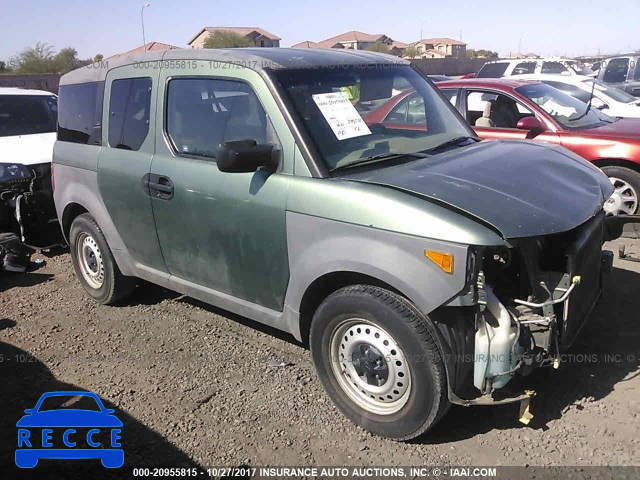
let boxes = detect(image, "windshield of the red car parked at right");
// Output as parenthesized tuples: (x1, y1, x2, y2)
(516, 83, 614, 129)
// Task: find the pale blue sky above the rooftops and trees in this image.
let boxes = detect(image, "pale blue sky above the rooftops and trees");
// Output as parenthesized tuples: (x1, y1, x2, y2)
(0, 0, 640, 60)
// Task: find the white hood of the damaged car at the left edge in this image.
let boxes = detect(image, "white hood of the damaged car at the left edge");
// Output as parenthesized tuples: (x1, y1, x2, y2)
(0, 132, 56, 165)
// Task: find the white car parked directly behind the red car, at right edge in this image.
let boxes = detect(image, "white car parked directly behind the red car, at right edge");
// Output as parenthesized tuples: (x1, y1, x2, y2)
(518, 75, 640, 118)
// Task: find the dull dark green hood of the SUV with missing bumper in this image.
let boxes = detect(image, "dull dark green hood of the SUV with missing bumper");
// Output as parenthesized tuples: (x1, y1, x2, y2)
(343, 140, 613, 238)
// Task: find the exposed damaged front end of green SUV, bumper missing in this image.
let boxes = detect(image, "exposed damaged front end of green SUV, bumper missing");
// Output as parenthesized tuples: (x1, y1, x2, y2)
(448, 212, 640, 414)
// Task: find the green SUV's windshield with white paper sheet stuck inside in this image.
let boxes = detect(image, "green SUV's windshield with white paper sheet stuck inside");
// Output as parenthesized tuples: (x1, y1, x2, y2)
(274, 64, 473, 170)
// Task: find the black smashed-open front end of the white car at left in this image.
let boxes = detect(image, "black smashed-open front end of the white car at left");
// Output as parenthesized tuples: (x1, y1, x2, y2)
(0, 163, 64, 250)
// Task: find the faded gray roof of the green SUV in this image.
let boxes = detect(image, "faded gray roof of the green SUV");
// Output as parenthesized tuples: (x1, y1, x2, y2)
(60, 48, 409, 85)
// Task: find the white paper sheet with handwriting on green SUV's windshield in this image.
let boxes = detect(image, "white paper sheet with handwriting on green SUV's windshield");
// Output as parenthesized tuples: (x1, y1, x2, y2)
(313, 92, 371, 140)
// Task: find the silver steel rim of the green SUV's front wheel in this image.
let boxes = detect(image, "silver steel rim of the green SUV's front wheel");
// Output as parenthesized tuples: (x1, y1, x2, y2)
(330, 318, 411, 415)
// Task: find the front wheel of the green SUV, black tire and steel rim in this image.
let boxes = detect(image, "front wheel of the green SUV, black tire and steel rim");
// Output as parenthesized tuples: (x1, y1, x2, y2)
(309, 285, 450, 440)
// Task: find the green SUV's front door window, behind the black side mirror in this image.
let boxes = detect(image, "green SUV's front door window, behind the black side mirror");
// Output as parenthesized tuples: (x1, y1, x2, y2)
(165, 78, 274, 158)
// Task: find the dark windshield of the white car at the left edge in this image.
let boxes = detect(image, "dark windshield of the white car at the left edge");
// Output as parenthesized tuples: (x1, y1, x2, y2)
(0, 95, 58, 137)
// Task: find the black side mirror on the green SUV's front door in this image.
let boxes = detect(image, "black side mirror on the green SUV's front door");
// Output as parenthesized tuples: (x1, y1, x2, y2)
(216, 140, 279, 173)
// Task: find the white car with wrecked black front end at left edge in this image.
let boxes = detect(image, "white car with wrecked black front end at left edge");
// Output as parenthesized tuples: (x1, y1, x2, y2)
(0, 88, 62, 248)
